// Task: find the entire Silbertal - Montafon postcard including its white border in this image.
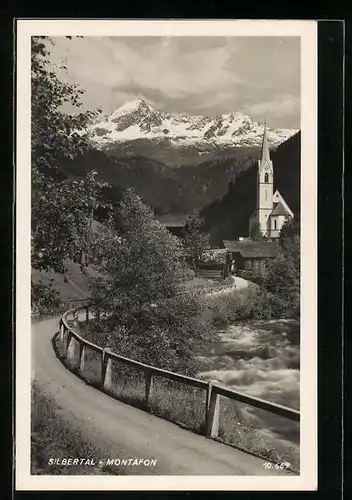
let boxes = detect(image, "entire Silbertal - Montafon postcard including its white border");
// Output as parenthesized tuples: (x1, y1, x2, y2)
(15, 19, 317, 491)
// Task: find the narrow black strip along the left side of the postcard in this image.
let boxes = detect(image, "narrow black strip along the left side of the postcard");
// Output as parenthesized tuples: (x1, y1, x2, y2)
(0, 8, 15, 498)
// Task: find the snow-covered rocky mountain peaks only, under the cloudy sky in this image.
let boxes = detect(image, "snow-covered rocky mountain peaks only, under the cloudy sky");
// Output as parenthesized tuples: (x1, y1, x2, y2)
(89, 99, 297, 155)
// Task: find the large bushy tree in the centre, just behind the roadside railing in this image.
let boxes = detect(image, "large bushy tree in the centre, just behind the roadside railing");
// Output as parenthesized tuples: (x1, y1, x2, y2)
(91, 189, 207, 372)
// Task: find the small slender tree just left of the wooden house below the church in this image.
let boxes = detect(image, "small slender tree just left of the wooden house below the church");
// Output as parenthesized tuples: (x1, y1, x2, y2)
(183, 213, 210, 270)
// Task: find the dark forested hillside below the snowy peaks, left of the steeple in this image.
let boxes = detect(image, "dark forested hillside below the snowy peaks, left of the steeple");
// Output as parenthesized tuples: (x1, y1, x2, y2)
(61, 148, 259, 213)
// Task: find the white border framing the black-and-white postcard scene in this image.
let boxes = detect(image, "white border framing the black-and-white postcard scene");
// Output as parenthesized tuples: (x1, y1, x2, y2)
(15, 19, 317, 491)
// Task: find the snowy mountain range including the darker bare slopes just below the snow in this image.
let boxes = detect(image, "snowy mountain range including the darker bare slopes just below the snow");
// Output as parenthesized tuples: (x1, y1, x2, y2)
(87, 98, 298, 167)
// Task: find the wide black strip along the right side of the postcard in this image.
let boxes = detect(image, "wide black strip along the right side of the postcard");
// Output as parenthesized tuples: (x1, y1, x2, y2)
(318, 21, 344, 498)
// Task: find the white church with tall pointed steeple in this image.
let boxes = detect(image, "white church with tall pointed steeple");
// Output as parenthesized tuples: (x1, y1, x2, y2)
(249, 125, 293, 239)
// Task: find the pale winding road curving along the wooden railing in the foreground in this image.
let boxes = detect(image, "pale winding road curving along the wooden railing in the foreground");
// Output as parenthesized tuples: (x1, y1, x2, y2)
(32, 318, 289, 476)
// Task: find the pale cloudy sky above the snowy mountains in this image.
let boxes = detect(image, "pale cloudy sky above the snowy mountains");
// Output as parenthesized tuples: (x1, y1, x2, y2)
(46, 36, 301, 129)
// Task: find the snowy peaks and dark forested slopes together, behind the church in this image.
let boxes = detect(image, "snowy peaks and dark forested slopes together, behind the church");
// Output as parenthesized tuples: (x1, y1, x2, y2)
(61, 100, 300, 229)
